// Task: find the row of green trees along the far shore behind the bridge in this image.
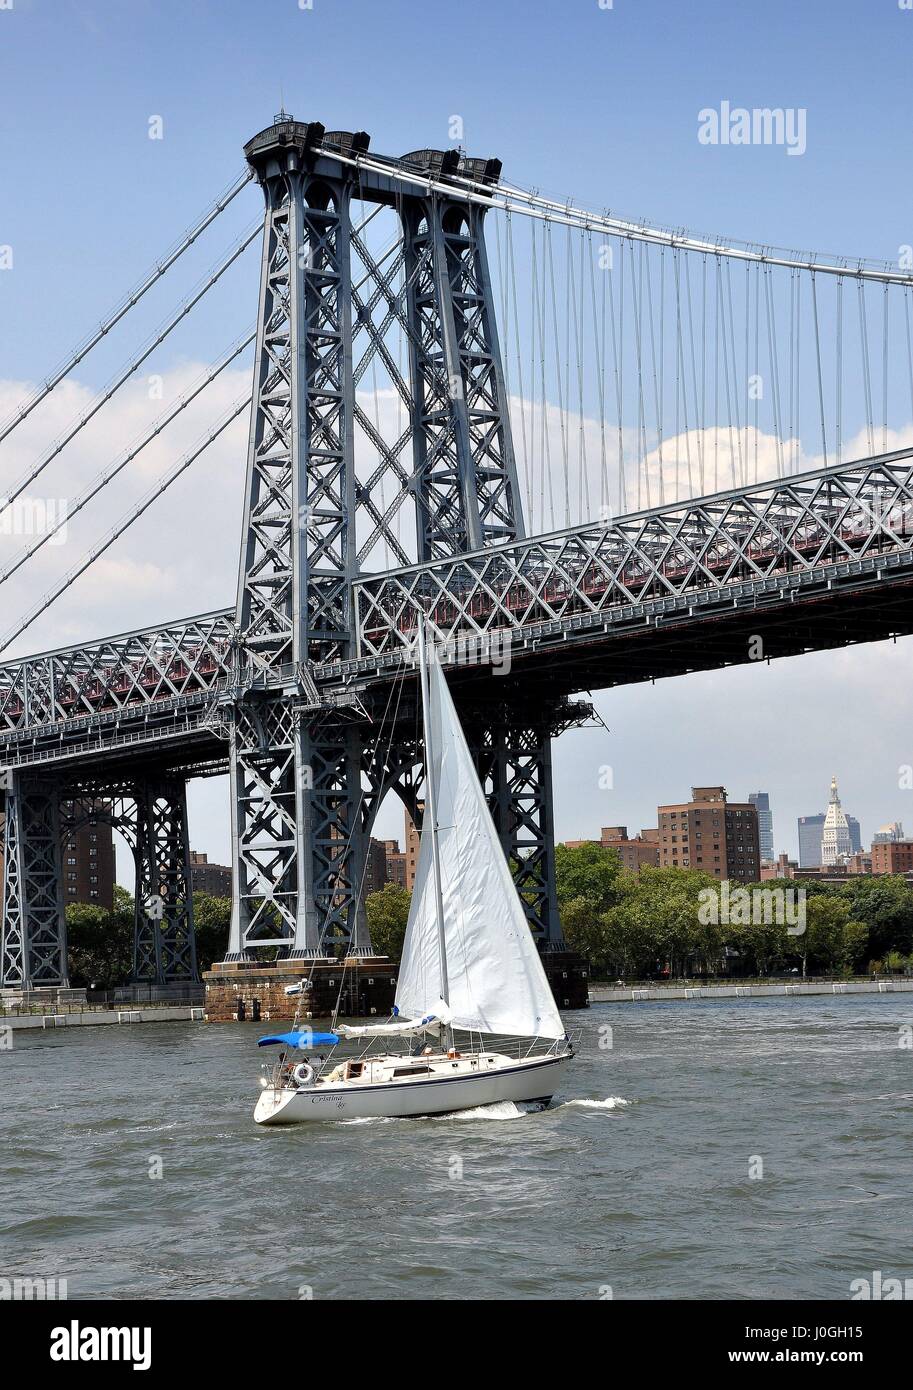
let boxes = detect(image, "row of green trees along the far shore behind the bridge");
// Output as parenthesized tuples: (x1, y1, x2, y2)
(58, 845, 913, 990)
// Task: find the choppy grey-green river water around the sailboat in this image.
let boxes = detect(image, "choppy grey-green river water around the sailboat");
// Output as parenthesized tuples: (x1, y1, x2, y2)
(0, 995, 913, 1298)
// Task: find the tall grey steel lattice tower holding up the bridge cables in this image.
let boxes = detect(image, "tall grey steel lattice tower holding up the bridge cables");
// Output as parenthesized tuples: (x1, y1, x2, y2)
(220, 113, 557, 962)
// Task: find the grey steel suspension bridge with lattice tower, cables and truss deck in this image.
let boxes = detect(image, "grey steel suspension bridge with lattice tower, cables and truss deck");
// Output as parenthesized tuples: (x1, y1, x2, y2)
(0, 113, 913, 988)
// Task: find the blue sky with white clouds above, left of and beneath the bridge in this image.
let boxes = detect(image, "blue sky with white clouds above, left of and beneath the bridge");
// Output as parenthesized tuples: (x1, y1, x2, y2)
(0, 0, 913, 872)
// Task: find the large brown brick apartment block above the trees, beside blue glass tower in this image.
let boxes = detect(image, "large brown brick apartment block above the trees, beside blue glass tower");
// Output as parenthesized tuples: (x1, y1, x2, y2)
(657, 787, 760, 883)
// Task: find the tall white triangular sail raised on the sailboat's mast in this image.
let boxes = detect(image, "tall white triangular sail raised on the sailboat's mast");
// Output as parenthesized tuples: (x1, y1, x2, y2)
(396, 644, 566, 1038)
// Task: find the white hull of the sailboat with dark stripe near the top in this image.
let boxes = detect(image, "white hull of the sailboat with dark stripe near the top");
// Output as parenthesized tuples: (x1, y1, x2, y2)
(254, 1052, 574, 1125)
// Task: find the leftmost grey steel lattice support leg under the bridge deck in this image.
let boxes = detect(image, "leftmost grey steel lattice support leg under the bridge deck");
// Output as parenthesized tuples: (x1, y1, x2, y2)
(0, 773, 68, 988)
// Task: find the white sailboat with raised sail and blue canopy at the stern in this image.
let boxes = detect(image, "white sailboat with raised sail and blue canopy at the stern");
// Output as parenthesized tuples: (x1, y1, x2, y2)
(254, 624, 574, 1125)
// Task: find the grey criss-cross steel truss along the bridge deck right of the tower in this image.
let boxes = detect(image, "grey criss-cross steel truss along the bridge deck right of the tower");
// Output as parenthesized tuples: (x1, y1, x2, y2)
(354, 450, 913, 657)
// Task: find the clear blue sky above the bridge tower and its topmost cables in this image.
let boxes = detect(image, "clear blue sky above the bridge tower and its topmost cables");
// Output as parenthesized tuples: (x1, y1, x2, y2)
(0, 0, 913, 375)
